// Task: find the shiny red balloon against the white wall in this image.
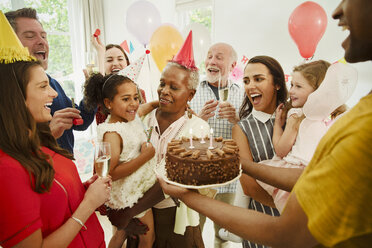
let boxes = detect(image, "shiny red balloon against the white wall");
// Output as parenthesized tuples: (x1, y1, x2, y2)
(288, 1, 327, 59)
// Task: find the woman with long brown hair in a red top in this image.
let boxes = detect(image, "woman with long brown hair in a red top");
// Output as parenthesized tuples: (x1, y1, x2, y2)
(0, 58, 110, 248)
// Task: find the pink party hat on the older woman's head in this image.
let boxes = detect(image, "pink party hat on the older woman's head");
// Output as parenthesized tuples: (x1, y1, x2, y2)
(171, 30, 198, 70)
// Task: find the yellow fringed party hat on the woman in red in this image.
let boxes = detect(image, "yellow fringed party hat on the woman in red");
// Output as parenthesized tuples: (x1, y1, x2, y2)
(0, 11, 36, 64)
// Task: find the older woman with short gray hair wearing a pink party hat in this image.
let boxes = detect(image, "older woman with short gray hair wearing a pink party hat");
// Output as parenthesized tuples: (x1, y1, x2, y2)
(144, 34, 209, 248)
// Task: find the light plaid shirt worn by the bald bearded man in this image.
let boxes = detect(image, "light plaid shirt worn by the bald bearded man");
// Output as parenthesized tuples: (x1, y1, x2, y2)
(190, 81, 244, 193)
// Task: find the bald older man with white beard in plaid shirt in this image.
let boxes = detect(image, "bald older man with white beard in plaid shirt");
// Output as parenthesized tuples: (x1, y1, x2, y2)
(190, 43, 244, 248)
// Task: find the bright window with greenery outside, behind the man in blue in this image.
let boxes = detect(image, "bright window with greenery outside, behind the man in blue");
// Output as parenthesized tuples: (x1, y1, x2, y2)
(0, 0, 94, 165)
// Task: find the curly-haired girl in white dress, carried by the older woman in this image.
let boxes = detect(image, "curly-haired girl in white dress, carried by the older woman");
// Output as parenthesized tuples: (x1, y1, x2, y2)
(84, 74, 156, 247)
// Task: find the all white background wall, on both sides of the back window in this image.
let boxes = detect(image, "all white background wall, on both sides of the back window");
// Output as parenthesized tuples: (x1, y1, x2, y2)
(104, 0, 372, 105)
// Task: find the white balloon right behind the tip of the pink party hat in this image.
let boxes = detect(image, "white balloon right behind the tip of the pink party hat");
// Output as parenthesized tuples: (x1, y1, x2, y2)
(182, 23, 211, 67)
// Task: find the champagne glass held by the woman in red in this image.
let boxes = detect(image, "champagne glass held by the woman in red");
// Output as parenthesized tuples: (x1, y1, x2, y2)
(94, 142, 111, 177)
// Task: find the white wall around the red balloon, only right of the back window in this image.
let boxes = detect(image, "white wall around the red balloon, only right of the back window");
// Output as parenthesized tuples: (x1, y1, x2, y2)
(212, 0, 372, 106)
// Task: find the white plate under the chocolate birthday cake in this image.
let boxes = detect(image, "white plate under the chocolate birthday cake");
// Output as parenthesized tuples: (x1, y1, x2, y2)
(155, 159, 242, 189)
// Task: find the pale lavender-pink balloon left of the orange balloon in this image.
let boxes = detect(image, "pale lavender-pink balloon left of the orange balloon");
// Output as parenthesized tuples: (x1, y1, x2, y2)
(126, 0, 161, 46)
